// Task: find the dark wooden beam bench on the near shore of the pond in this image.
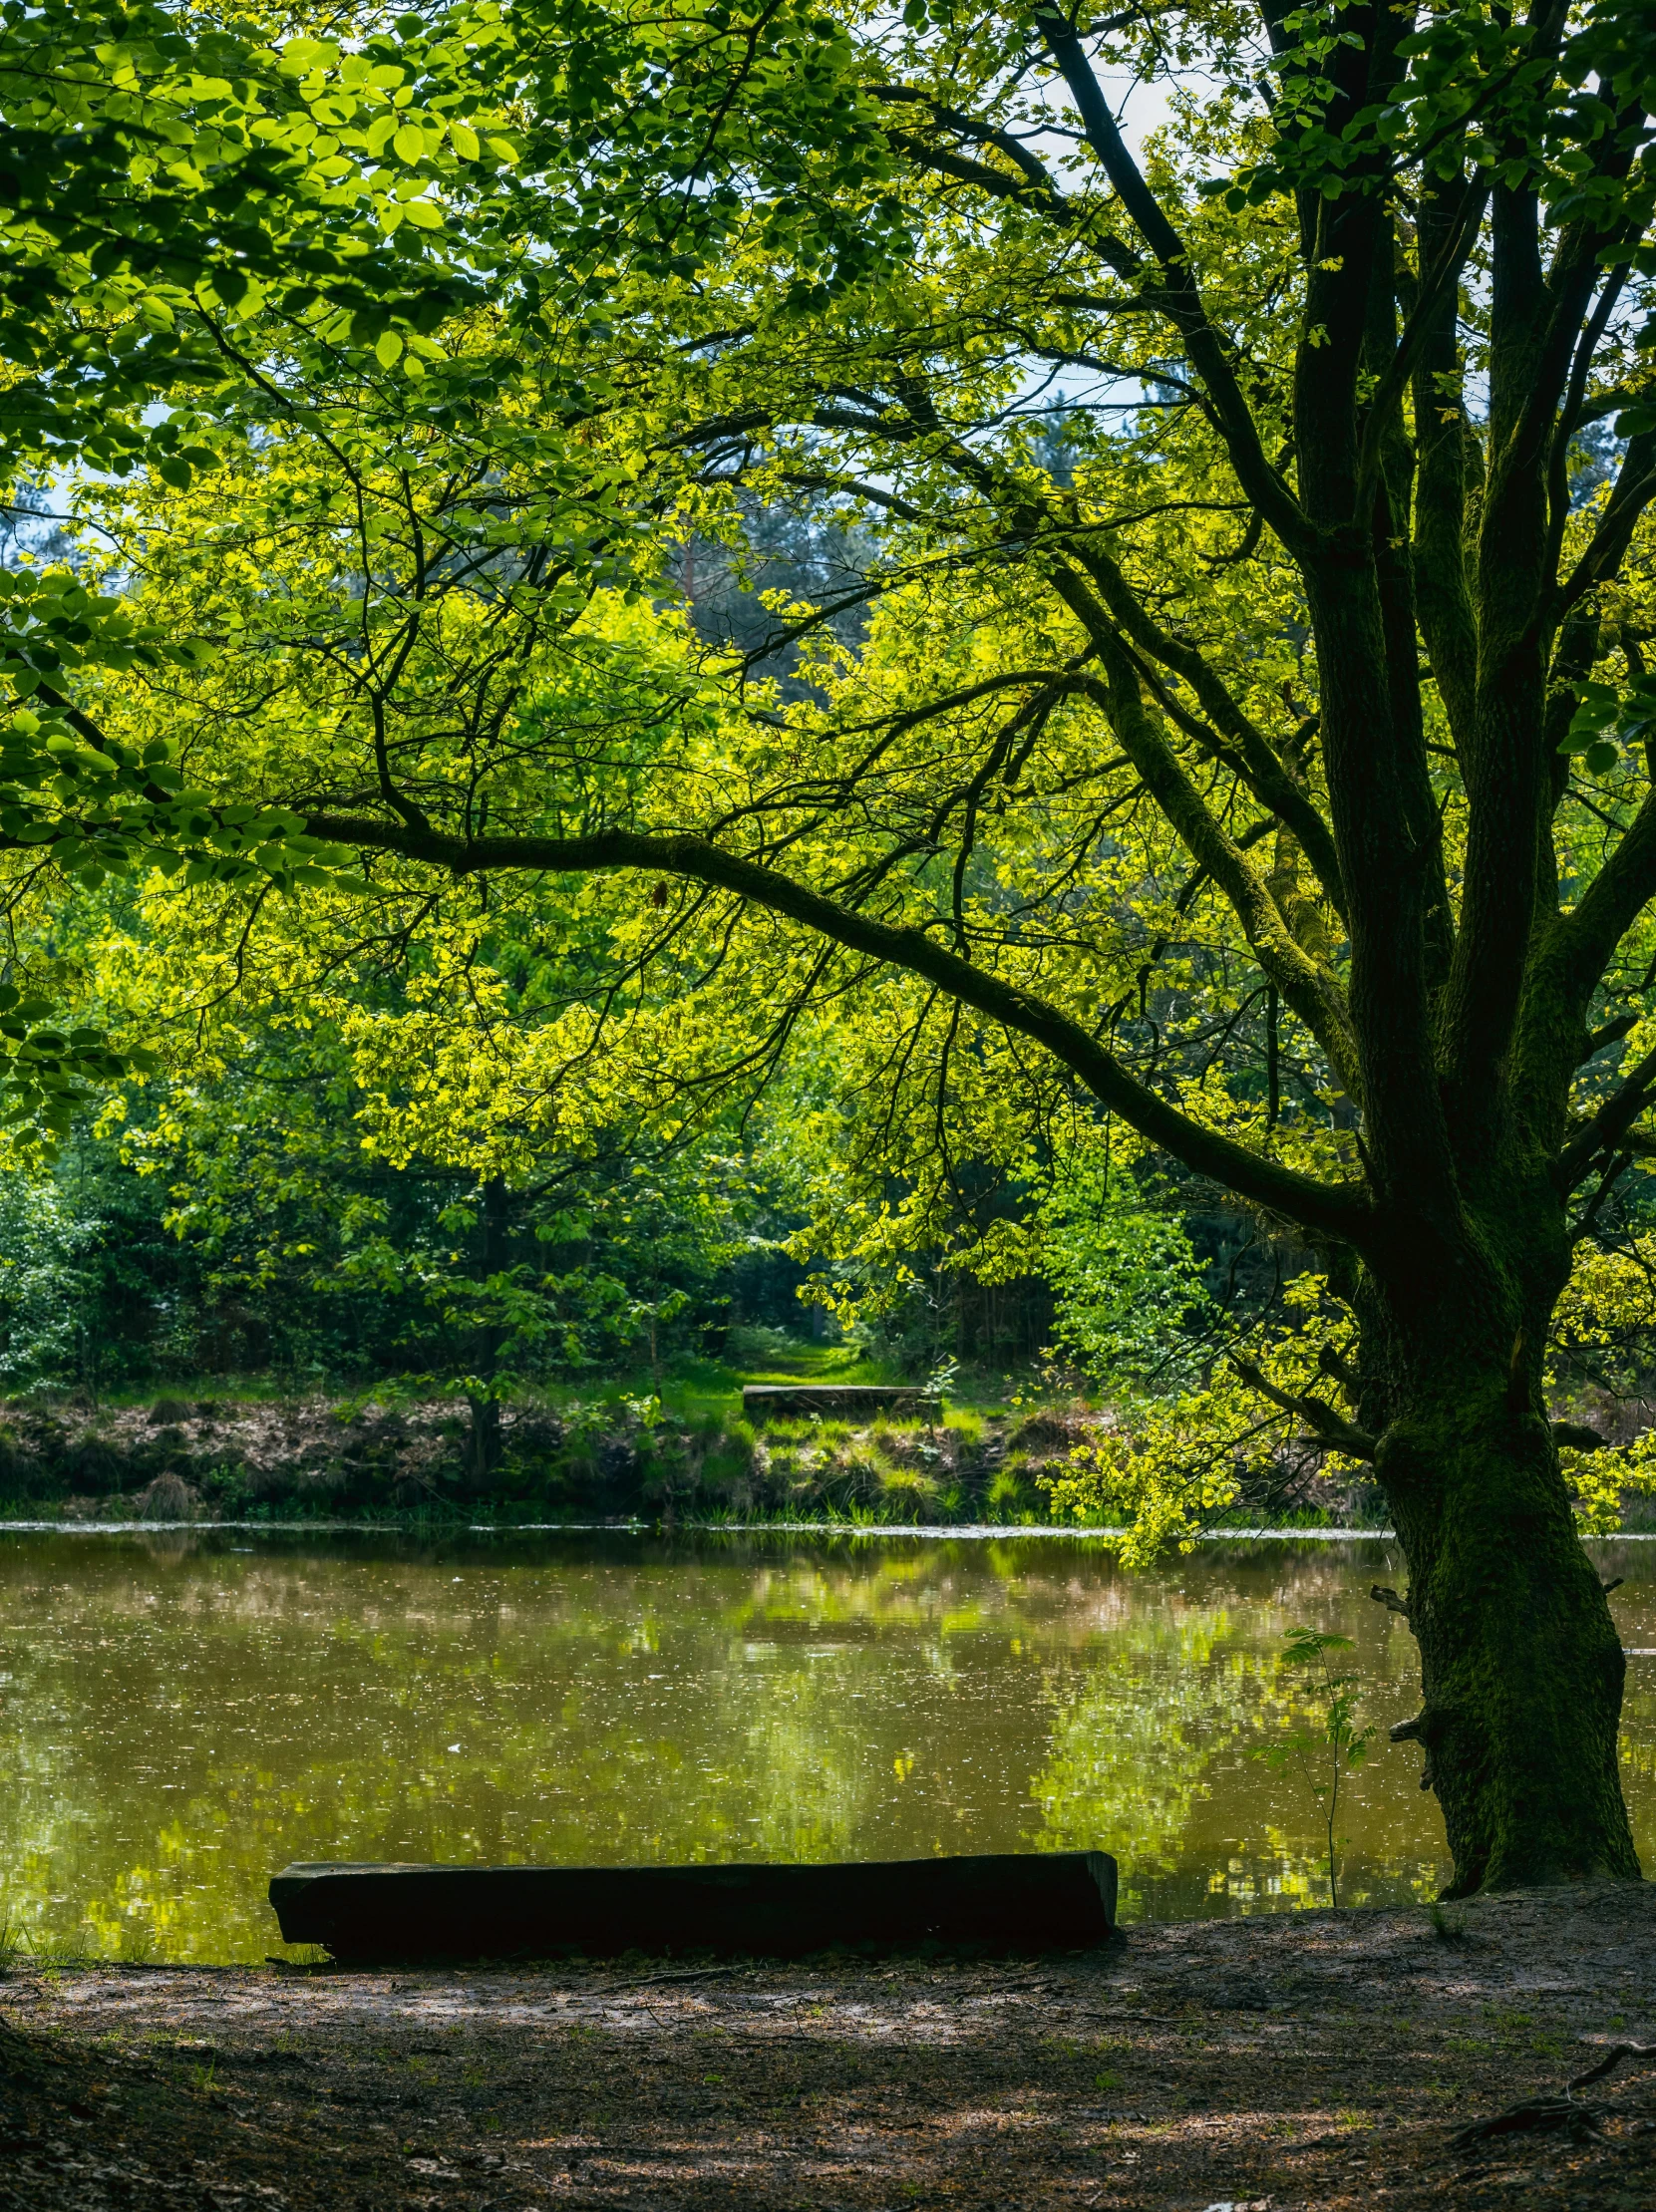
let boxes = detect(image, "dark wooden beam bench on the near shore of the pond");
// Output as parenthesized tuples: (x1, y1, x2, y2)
(270, 1851, 1117, 1958)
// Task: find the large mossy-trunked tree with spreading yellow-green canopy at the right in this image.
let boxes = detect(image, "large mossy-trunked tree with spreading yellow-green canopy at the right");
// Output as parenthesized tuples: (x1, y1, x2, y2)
(12, 0, 1656, 1891)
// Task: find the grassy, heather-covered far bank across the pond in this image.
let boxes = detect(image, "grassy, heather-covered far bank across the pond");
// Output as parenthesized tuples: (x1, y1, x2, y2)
(0, 1372, 1380, 1526)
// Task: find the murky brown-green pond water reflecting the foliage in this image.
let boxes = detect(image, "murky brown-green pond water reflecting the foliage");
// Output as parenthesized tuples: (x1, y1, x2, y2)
(0, 1528, 1656, 1960)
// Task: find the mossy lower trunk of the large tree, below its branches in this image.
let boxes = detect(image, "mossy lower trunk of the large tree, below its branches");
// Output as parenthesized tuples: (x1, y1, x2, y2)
(1371, 1203, 1640, 1896)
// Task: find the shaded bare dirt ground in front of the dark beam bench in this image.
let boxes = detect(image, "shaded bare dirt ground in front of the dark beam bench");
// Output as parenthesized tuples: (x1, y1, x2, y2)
(0, 1885, 1656, 2212)
